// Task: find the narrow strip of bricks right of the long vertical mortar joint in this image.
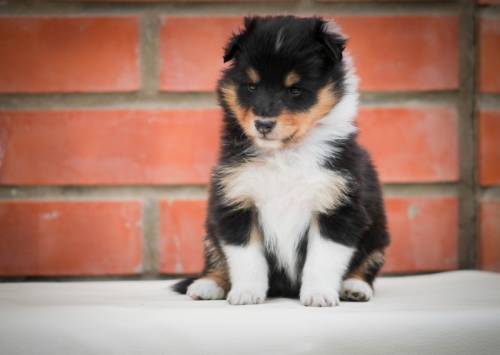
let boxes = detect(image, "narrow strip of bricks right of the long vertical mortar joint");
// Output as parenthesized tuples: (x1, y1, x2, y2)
(477, 4, 500, 271)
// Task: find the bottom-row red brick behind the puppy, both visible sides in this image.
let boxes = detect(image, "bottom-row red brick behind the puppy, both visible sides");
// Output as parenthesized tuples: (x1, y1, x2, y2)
(160, 196, 458, 274)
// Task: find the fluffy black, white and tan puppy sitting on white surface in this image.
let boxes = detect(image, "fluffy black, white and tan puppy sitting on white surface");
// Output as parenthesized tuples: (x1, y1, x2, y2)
(174, 16, 389, 307)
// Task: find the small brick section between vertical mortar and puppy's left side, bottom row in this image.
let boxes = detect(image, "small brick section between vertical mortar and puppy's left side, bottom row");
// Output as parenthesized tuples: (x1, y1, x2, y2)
(160, 200, 206, 274)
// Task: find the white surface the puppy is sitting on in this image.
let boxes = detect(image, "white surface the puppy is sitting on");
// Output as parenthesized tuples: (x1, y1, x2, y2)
(0, 271, 500, 355)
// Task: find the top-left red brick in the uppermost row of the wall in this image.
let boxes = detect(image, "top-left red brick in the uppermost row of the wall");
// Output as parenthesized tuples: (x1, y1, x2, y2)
(0, 17, 139, 93)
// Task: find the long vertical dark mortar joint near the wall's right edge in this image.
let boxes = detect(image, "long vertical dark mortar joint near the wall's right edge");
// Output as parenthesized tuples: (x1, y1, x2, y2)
(458, 0, 478, 269)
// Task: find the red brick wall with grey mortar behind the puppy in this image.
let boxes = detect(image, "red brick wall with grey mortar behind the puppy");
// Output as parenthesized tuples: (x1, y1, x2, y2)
(0, 0, 500, 277)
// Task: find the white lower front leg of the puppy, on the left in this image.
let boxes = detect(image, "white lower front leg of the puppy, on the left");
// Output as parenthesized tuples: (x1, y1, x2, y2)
(223, 240, 269, 305)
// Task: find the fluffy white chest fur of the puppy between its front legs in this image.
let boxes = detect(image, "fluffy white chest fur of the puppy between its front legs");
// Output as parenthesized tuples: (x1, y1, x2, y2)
(224, 151, 346, 281)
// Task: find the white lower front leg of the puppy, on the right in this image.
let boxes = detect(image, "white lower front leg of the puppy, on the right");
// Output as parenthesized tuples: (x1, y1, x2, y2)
(300, 222, 354, 307)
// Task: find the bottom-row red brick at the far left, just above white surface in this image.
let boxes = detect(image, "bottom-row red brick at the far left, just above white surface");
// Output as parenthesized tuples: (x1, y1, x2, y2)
(0, 201, 142, 276)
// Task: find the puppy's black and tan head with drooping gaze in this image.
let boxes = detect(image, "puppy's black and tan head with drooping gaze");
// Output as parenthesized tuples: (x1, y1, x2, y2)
(218, 16, 345, 149)
